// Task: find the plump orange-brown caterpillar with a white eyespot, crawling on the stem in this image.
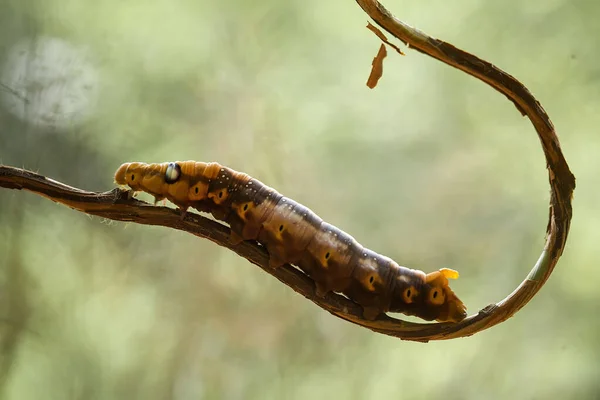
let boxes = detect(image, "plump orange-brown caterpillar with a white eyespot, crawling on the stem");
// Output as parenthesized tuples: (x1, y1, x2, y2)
(115, 161, 467, 322)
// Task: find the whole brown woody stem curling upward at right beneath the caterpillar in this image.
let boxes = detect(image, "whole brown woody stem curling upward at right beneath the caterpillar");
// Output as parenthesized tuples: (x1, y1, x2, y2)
(0, 0, 575, 342)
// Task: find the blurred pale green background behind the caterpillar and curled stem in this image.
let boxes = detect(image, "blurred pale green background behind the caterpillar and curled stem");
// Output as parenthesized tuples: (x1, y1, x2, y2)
(0, 0, 600, 400)
